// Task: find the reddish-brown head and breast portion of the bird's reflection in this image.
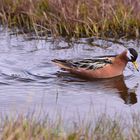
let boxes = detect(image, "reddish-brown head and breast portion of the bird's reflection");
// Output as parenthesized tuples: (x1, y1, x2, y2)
(98, 76, 137, 104)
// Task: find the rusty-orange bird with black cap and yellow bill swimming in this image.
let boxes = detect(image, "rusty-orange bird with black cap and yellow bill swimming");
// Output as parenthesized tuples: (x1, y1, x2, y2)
(52, 48, 139, 79)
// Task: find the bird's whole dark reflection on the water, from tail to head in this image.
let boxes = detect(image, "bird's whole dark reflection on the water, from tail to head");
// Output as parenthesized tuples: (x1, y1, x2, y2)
(57, 72, 137, 105)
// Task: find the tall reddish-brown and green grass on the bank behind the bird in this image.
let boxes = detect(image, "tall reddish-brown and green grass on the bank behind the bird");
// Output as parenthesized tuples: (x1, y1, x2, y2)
(0, 0, 140, 37)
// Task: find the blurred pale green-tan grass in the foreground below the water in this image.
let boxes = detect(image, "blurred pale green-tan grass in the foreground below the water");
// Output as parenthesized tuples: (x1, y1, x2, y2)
(0, 113, 140, 140)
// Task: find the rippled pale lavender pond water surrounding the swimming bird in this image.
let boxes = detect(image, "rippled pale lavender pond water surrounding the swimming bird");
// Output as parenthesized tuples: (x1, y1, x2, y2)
(0, 28, 140, 119)
